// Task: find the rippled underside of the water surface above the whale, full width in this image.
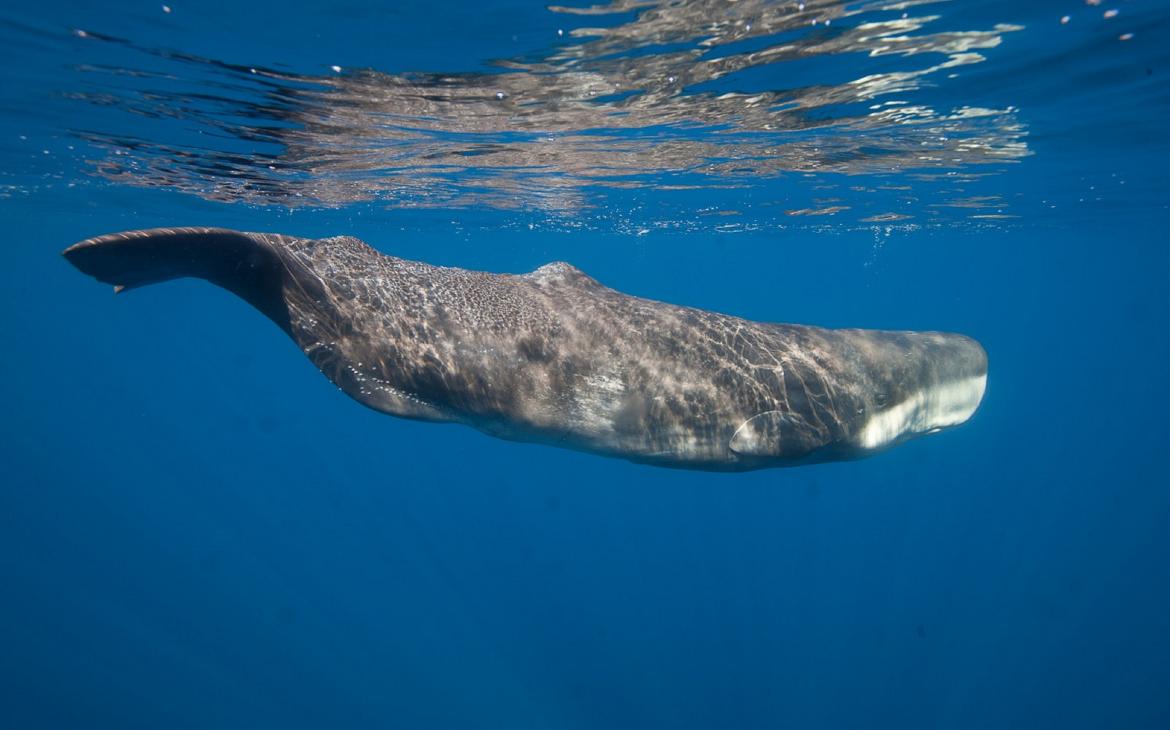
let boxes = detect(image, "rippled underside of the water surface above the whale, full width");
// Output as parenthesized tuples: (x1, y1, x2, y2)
(5, 0, 1168, 229)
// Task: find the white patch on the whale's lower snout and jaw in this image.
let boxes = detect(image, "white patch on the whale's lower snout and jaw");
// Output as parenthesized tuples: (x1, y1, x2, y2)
(854, 373, 987, 450)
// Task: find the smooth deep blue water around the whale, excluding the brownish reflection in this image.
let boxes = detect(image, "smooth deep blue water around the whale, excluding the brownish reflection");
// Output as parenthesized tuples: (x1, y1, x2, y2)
(0, 1, 1170, 729)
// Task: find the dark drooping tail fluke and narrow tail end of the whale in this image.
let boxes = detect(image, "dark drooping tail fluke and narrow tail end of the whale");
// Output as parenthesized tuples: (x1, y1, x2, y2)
(63, 228, 300, 331)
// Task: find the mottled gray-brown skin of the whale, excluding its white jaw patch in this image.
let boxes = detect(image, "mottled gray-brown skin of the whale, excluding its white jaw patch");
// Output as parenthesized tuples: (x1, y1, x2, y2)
(66, 228, 986, 470)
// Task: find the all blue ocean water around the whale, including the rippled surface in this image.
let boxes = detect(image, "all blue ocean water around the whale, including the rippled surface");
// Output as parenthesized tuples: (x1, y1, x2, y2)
(0, 0, 1170, 729)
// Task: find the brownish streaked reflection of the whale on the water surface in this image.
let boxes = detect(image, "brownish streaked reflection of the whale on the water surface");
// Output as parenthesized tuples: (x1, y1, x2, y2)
(76, 0, 1028, 221)
